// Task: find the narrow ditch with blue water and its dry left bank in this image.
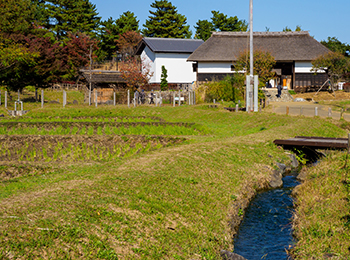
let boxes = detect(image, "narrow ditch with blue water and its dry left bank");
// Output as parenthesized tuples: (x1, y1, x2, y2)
(220, 153, 305, 260)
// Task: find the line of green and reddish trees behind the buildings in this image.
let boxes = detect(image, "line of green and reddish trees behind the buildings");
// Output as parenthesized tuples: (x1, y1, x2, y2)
(0, 0, 350, 93)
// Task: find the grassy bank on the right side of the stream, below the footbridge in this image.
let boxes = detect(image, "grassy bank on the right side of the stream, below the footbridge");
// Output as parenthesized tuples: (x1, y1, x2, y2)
(293, 152, 350, 259)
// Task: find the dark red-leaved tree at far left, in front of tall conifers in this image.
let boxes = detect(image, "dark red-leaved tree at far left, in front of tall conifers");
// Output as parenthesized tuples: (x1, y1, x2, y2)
(0, 31, 94, 91)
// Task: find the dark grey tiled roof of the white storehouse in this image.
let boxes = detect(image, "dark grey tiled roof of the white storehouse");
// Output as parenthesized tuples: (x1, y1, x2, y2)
(136, 37, 203, 55)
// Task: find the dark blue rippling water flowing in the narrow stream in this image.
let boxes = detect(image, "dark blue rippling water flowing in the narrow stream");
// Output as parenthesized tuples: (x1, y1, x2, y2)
(234, 176, 299, 260)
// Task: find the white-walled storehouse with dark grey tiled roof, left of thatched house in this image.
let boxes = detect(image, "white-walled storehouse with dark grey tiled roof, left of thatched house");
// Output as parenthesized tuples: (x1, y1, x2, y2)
(136, 37, 203, 87)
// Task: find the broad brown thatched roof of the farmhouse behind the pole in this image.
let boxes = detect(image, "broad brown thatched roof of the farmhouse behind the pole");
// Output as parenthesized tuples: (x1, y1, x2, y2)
(187, 32, 329, 62)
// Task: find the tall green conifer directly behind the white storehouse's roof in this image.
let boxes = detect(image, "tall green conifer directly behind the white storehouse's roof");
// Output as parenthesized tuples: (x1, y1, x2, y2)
(143, 0, 192, 38)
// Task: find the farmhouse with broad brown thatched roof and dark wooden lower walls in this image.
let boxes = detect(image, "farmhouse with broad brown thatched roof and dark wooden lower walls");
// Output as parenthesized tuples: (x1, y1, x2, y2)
(187, 31, 329, 90)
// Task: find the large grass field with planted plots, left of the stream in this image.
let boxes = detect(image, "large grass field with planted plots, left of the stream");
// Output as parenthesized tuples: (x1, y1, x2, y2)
(0, 99, 346, 259)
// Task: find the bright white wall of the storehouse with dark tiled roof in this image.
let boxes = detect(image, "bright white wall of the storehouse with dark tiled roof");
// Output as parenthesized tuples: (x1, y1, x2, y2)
(141, 46, 196, 83)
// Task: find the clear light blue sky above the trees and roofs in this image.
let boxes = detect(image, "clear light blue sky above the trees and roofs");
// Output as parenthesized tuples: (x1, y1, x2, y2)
(90, 0, 350, 44)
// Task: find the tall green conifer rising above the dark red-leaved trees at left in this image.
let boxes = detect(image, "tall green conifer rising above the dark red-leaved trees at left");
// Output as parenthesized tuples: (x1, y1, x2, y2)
(39, 0, 100, 39)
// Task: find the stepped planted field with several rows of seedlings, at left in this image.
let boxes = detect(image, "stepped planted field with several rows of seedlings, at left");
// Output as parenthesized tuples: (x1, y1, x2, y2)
(0, 116, 203, 180)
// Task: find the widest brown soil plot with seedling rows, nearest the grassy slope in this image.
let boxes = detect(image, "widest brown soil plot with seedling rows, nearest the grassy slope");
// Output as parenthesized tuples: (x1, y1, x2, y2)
(0, 135, 185, 162)
